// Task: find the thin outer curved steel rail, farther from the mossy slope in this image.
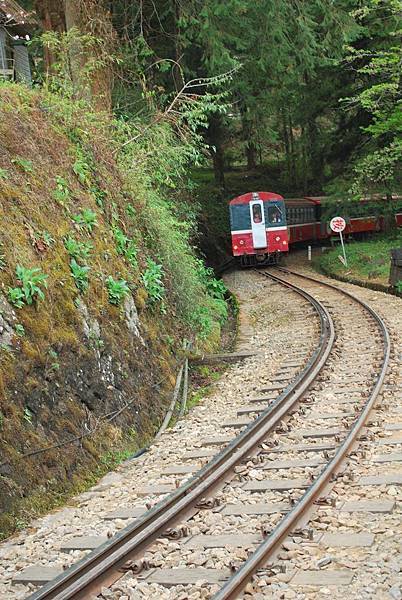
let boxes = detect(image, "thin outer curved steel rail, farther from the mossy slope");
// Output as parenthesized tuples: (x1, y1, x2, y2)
(212, 268, 391, 600)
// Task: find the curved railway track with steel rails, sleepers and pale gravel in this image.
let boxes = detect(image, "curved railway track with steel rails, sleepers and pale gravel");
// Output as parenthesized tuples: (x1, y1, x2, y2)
(22, 269, 390, 600)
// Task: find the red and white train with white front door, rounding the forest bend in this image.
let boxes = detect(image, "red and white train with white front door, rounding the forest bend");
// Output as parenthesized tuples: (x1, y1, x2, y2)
(229, 192, 402, 266)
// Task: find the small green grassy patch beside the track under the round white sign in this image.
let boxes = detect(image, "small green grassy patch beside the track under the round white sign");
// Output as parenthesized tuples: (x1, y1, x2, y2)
(314, 231, 402, 290)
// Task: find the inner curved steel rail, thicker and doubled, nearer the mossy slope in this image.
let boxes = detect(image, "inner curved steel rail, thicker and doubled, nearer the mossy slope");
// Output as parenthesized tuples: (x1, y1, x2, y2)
(29, 274, 335, 600)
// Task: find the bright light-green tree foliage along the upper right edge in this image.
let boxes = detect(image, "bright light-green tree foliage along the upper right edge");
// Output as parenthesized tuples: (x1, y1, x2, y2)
(344, 0, 402, 196)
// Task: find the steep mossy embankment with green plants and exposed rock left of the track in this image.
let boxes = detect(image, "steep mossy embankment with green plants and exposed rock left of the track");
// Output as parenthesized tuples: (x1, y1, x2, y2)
(0, 84, 226, 537)
